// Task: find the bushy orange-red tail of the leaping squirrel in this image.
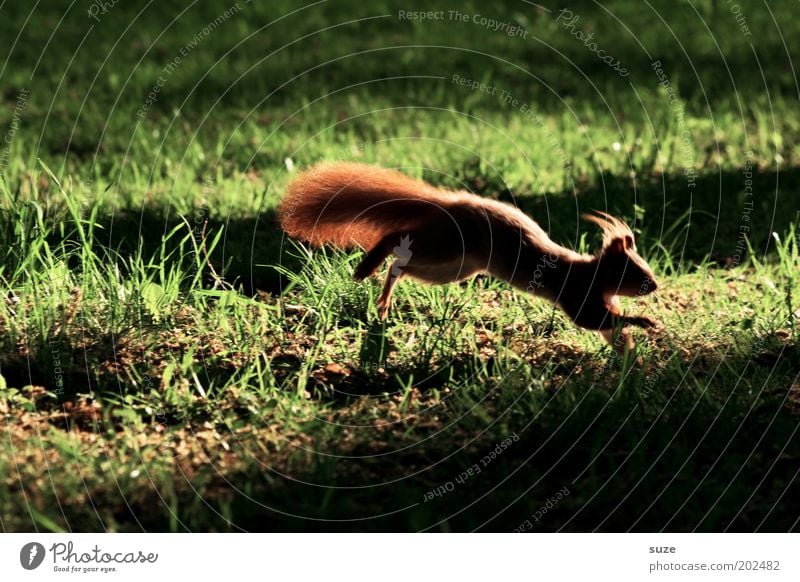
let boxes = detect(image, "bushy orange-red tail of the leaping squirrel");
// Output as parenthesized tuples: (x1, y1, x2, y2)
(278, 162, 448, 249)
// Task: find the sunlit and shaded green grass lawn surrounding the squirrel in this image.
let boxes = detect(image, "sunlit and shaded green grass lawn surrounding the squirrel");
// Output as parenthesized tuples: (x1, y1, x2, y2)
(0, 1, 800, 531)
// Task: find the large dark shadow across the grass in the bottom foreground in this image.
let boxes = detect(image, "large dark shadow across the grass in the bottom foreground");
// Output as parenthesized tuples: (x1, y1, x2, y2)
(37, 338, 800, 532)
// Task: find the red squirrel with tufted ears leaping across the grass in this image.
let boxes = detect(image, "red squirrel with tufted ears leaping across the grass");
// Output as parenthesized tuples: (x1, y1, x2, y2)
(278, 162, 658, 351)
